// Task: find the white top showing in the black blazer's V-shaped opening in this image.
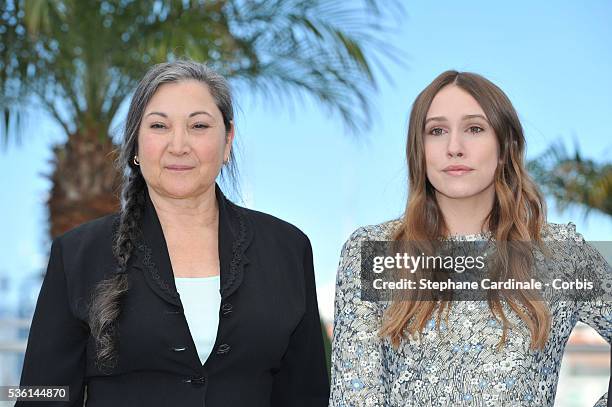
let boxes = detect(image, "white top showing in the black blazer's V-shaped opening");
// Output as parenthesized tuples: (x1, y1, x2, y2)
(174, 276, 221, 364)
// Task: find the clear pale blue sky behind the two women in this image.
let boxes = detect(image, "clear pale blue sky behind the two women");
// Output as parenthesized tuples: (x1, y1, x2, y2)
(0, 0, 612, 322)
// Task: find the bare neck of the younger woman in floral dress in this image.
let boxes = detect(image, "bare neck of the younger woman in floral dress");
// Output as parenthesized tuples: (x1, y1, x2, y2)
(436, 184, 495, 235)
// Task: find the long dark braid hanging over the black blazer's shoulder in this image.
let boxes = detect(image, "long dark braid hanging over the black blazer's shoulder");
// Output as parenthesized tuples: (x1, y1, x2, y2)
(89, 171, 145, 370)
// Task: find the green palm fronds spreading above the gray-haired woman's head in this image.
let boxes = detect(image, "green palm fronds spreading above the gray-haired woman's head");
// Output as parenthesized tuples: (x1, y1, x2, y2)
(0, 0, 401, 146)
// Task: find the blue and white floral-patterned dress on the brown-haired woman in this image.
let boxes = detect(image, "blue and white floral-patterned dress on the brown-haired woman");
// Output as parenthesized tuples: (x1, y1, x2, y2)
(329, 220, 612, 407)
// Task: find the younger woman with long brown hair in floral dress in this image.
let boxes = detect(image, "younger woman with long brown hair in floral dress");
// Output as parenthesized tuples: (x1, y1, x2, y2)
(330, 71, 612, 407)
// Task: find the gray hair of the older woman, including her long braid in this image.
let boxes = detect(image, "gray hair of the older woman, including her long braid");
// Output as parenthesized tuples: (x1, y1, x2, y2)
(89, 59, 236, 370)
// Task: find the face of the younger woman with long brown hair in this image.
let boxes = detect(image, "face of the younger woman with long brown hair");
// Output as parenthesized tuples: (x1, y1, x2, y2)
(423, 85, 499, 199)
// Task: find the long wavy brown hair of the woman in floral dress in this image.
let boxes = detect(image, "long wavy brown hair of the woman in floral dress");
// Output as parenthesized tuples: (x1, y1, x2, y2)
(379, 71, 551, 349)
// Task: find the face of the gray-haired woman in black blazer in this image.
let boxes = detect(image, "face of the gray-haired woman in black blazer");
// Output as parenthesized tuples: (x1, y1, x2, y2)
(137, 80, 234, 198)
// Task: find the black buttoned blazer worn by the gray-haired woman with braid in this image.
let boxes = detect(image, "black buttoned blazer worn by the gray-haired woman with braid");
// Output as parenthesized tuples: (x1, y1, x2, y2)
(16, 186, 329, 407)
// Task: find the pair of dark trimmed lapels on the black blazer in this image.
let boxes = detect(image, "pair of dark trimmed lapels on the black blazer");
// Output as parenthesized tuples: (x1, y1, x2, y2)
(132, 184, 253, 308)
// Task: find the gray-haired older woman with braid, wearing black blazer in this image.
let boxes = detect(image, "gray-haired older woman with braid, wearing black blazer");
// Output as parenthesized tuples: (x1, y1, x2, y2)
(17, 61, 329, 407)
